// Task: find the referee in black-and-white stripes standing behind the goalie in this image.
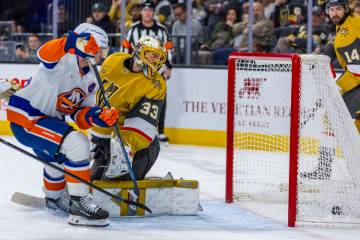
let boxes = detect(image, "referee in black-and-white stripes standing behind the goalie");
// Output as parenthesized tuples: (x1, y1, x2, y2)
(121, 0, 173, 145)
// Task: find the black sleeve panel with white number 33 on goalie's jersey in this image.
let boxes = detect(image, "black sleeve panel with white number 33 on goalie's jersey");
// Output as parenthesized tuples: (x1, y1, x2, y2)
(125, 97, 164, 127)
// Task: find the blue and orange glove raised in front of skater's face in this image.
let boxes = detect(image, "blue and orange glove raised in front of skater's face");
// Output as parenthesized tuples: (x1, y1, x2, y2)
(65, 32, 99, 58)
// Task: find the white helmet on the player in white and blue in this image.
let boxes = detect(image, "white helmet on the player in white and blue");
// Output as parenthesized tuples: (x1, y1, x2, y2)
(74, 23, 109, 58)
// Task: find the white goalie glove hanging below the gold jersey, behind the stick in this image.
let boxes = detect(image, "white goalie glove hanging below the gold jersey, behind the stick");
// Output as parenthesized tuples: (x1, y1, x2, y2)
(105, 138, 133, 178)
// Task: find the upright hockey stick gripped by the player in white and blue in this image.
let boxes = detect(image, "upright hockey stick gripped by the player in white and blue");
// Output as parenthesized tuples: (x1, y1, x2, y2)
(87, 58, 140, 209)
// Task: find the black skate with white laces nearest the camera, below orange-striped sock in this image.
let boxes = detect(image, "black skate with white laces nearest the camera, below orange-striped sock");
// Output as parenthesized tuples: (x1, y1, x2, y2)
(68, 195, 109, 227)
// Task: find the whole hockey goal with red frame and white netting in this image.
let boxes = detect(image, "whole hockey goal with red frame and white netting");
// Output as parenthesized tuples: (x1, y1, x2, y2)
(225, 53, 360, 227)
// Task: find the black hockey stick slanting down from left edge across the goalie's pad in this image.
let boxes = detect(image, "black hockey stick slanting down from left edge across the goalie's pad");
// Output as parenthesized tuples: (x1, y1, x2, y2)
(0, 138, 152, 213)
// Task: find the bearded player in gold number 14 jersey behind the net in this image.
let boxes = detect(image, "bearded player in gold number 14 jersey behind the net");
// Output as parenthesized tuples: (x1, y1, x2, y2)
(326, 0, 360, 132)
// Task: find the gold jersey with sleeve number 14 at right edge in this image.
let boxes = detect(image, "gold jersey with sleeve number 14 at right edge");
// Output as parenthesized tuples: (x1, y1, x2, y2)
(334, 15, 360, 92)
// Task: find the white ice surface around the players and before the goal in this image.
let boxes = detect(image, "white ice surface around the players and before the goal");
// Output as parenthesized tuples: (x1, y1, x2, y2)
(0, 138, 360, 240)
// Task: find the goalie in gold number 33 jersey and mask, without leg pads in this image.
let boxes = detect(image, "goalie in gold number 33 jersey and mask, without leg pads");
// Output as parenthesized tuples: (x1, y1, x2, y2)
(90, 36, 167, 180)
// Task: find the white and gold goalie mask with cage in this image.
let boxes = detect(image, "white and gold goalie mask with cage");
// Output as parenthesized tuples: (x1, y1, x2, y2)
(133, 35, 167, 79)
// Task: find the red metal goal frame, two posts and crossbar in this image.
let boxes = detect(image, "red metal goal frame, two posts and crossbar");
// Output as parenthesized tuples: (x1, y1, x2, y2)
(225, 53, 301, 227)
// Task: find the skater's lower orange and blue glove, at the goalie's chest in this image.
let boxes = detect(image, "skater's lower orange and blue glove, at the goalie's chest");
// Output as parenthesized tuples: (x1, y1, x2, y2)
(85, 107, 119, 127)
